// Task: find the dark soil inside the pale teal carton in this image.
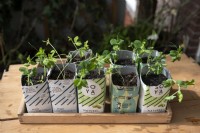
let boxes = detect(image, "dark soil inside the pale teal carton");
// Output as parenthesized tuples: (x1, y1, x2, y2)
(112, 73, 137, 86)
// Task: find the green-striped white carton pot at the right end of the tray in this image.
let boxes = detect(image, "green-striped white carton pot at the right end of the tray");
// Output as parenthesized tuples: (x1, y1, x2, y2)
(139, 67, 171, 113)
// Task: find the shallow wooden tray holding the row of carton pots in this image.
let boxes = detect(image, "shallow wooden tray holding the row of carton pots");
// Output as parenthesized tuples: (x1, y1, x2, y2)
(18, 100, 172, 124)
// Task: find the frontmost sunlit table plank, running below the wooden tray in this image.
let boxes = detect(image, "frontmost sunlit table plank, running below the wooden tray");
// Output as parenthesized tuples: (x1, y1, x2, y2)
(1, 120, 200, 133)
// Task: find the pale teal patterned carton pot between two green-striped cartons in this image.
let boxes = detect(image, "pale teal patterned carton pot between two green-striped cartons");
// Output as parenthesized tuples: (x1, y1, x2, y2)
(110, 67, 140, 113)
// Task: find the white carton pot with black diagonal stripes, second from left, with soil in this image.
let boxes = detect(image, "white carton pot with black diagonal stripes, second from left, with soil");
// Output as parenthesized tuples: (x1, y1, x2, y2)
(48, 63, 77, 113)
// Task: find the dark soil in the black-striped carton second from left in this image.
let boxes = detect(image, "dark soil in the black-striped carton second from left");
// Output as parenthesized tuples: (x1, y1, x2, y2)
(49, 69, 75, 80)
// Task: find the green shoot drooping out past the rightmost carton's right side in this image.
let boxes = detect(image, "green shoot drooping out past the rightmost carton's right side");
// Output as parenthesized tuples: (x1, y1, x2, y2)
(163, 79, 194, 102)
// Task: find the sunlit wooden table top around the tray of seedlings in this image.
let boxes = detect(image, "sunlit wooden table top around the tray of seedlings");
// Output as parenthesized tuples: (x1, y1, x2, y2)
(0, 55, 200, 133)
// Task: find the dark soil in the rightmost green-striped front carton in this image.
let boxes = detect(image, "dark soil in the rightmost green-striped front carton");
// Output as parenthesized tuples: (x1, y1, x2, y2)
(142, 74, 167, 86)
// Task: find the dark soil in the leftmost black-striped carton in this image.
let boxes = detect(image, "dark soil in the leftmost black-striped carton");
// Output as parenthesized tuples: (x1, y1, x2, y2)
(22, 74, 46, 86)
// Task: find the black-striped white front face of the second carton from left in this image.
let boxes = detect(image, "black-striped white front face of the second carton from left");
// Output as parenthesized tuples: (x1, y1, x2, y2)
(49, 80, 77, 113)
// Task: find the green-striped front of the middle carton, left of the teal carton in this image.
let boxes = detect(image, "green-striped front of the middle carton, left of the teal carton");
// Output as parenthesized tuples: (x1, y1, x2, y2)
(78, 78, 106, 113)
